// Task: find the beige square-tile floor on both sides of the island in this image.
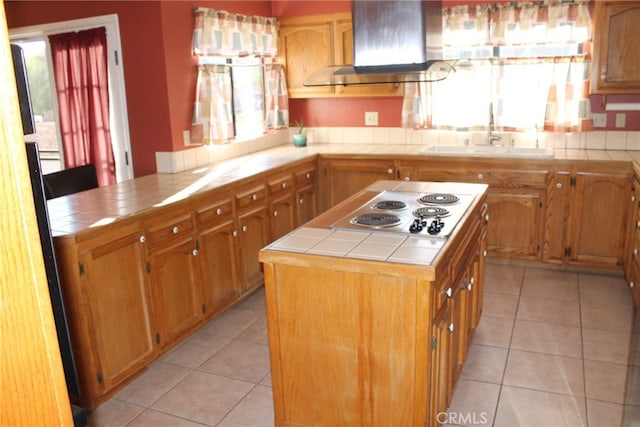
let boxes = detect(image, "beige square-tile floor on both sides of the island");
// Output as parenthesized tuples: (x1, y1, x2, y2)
(89, 264, 640, 427)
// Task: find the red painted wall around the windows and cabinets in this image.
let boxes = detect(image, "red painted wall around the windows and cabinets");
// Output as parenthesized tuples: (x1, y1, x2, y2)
(4, 0, 640, 176)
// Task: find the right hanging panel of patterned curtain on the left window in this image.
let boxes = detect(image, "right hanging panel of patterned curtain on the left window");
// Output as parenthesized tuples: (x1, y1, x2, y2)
(264, 64, 289, 129)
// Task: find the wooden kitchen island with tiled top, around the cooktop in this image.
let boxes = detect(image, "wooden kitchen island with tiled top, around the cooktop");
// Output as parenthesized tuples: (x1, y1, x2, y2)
(260, 181, 487, 426)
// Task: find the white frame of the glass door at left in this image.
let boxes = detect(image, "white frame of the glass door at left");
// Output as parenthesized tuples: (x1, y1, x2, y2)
(9, 14, 133, 182)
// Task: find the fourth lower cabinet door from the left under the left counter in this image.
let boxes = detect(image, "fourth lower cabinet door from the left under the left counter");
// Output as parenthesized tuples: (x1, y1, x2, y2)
(238, 207, 268, 294)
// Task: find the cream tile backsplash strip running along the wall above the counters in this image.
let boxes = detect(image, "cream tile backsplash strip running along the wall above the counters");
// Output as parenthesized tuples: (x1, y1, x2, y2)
(156, 127, 640, 173)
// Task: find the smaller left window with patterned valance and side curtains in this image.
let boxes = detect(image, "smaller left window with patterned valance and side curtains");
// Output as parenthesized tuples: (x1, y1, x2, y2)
(191, 8, 289, 144)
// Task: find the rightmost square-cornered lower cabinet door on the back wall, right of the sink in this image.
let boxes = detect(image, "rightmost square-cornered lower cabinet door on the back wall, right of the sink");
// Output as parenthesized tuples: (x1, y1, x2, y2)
(570, 172, 631, 267)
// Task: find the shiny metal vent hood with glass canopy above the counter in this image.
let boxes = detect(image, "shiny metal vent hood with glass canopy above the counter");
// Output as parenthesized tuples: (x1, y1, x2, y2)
(304, 0, 455, 86)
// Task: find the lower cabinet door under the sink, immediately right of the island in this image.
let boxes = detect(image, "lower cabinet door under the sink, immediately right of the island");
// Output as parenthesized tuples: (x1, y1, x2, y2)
(487, 189, 543, 260)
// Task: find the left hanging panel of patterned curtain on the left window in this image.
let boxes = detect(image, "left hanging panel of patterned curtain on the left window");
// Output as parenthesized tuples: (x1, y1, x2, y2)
(191, 64, 235, 144)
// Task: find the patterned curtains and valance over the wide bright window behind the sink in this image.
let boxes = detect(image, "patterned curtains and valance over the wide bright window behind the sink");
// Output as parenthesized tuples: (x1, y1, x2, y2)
(403, 0, 591, 131)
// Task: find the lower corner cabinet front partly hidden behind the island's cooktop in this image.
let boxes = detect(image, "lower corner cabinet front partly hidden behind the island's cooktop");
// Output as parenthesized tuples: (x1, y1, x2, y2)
(320, 157, 396, 211)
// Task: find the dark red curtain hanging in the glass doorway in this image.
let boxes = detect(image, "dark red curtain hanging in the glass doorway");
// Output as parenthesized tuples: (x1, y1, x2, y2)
(49, 27, 116, 186)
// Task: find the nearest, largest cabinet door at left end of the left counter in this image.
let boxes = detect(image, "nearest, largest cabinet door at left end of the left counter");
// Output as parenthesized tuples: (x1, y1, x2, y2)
(56, 224, 156, 408)
